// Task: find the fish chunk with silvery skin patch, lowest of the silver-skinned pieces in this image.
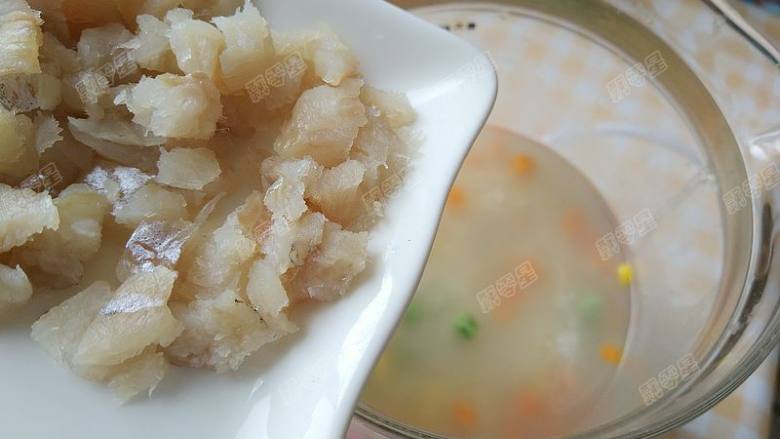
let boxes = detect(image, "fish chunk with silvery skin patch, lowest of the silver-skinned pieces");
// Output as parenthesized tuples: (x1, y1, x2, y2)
(73, 267, 182, 366)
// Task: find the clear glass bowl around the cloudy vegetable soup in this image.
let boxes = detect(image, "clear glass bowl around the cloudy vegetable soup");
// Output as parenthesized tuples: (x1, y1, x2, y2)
(352, 0, 780, 439)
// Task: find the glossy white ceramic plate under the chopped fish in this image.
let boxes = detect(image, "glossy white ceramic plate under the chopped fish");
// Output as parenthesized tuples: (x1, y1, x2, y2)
(0, 0, 497, 439)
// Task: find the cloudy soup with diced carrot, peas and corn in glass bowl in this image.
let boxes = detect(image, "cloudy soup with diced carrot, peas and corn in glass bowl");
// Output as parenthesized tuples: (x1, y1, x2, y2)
(361, 126, 632, 439)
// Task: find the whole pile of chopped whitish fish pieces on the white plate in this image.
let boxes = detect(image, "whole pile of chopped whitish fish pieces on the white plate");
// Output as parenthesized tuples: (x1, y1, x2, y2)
(0, 0, 414, 401)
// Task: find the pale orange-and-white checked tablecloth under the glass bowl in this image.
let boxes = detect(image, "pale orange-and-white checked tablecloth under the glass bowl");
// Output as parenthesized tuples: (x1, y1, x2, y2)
(348, 0, 780, 439)
